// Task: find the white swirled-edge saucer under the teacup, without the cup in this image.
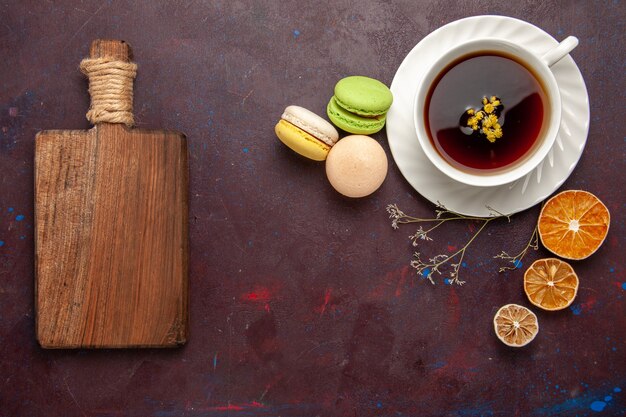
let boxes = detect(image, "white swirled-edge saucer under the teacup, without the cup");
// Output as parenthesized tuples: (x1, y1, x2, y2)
(387, 16, 589, 216)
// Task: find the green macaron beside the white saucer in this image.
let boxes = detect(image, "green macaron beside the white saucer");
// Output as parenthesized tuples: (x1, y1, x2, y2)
(327, 76, 393, 135)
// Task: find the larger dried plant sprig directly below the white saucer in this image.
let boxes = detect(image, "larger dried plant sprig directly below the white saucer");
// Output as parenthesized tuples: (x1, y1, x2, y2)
(387, 202, 511, 285)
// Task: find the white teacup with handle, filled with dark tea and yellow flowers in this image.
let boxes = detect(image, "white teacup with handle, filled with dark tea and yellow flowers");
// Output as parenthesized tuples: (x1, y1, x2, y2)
(414, 37, 578, 186)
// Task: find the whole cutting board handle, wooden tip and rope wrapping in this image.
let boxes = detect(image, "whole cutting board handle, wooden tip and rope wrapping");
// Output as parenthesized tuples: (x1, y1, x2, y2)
(80, 39, 137, 127)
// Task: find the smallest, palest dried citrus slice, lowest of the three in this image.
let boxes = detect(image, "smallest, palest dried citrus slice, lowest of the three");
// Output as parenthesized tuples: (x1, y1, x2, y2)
(493, 304, 539, 347)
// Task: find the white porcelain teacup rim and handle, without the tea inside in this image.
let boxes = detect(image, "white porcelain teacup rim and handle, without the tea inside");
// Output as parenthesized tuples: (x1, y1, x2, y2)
(413, 36, 578, 187)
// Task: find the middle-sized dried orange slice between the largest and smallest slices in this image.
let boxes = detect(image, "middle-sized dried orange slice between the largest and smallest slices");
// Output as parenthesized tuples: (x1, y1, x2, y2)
(524, 258, 578, 311)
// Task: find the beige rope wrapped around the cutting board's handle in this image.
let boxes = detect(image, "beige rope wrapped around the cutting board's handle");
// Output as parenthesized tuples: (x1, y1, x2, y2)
(80, 58, 137, 127)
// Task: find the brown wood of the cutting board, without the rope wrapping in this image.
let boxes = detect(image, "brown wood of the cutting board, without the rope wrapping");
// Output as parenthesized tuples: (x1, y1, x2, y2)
(35, 40, 188, 348)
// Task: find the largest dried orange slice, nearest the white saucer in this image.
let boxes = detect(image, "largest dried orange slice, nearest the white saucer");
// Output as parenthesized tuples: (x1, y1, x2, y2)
(538, 190, 611, 260)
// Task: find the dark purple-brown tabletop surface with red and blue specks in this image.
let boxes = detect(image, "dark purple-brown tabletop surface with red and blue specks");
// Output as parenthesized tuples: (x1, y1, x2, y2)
(0, 0, 626, 417)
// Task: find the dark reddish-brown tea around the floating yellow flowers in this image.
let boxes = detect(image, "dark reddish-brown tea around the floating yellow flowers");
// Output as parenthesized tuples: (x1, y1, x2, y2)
(424, 51, 548, 173)
